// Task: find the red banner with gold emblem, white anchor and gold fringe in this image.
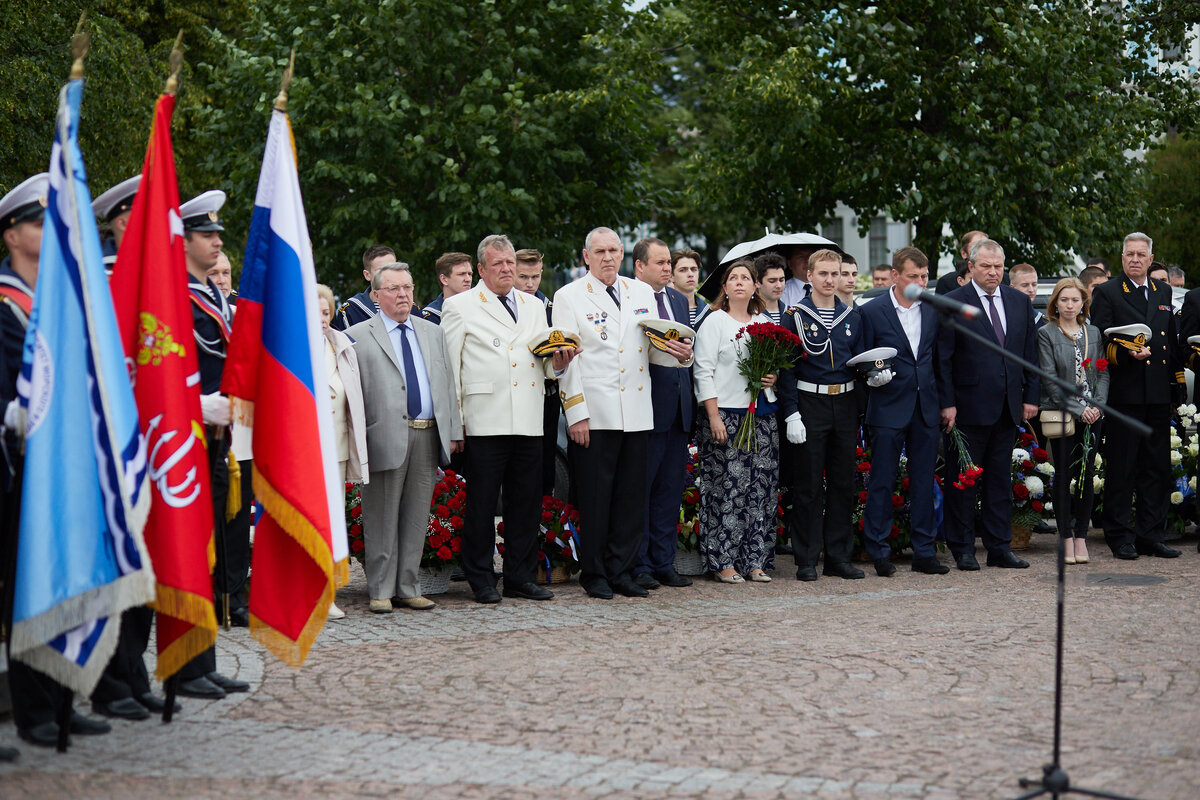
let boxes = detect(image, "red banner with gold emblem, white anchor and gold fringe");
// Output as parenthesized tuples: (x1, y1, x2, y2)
(110, 95, 217, 680)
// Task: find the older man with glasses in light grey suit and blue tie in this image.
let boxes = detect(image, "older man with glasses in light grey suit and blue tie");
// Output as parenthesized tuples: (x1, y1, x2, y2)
(346, 263, 462, 614)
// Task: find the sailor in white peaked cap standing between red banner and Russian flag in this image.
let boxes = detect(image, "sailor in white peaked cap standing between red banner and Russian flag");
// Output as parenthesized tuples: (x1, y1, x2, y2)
(179, 190, 250, 699)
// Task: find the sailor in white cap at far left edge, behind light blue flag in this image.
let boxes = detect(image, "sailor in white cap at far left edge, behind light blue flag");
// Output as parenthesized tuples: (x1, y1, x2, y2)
(0, 173, 112, 756)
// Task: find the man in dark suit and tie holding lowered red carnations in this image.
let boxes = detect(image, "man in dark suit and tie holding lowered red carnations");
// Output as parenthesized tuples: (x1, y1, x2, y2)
(937, 239, 1039, 570)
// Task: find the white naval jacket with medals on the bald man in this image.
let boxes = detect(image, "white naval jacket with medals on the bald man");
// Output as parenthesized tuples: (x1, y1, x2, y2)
(553, 272, 658, 432)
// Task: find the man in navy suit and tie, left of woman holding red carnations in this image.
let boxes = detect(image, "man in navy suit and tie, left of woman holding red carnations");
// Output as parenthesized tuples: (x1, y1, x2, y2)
(634, 237, 696, 589)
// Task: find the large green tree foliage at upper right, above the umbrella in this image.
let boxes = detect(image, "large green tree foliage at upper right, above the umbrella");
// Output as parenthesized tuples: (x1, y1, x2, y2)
(678, 0, 1189, 265)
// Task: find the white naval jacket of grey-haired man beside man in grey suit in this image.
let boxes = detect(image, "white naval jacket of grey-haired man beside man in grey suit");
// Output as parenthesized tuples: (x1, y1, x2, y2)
(442, 281, 554, 437)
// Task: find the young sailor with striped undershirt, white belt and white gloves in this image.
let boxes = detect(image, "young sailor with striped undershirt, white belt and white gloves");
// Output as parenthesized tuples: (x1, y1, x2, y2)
(779, 249, 892, 581)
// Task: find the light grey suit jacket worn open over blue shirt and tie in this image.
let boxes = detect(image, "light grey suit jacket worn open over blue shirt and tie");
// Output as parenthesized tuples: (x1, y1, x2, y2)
(346, 314, 462, 473)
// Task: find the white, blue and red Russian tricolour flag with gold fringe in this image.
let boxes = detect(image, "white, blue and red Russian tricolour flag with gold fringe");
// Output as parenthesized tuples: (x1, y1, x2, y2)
(222, 110, 349, 666)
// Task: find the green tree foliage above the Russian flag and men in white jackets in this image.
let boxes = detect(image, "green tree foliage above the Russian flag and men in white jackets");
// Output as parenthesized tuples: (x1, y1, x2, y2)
(198, 0, 652, 299)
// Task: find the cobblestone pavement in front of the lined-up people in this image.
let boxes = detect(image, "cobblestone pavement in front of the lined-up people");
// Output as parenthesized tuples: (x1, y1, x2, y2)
(0, 536, 1200, 800)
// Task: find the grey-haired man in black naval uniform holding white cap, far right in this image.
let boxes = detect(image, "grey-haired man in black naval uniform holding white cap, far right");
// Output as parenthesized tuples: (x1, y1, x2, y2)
(1092, 233, 1194, 560)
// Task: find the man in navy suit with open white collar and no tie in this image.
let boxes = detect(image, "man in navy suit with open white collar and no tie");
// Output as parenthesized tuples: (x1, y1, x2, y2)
(858, 247, 949, 578)
